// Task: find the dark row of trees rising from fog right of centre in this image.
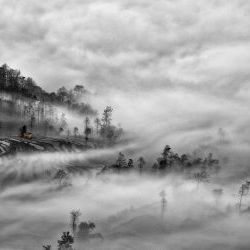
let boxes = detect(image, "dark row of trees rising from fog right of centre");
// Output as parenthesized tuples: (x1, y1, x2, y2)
(103, 145, 220, 178)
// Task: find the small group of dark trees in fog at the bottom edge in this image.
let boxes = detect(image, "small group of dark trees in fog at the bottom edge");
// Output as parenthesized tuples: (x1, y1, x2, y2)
(43, 210, 103, 250)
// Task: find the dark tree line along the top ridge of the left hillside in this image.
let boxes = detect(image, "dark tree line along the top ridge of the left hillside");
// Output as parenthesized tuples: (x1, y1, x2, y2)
(0, 64, 97, 115)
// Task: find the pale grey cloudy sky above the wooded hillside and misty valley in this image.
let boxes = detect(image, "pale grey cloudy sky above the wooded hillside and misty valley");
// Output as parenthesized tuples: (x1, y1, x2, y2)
(0, 0, 250, 156)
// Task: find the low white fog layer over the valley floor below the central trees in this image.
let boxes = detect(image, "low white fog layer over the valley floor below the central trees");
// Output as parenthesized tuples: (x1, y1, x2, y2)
(0, 145, 250, 250)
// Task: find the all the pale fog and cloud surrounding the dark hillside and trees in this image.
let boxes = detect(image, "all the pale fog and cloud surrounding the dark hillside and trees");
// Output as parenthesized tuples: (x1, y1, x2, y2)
(0, 0, 250, 250)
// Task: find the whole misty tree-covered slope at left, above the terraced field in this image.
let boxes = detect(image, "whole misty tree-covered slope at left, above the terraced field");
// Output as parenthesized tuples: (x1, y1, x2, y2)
(0, 64, 123, 142)
